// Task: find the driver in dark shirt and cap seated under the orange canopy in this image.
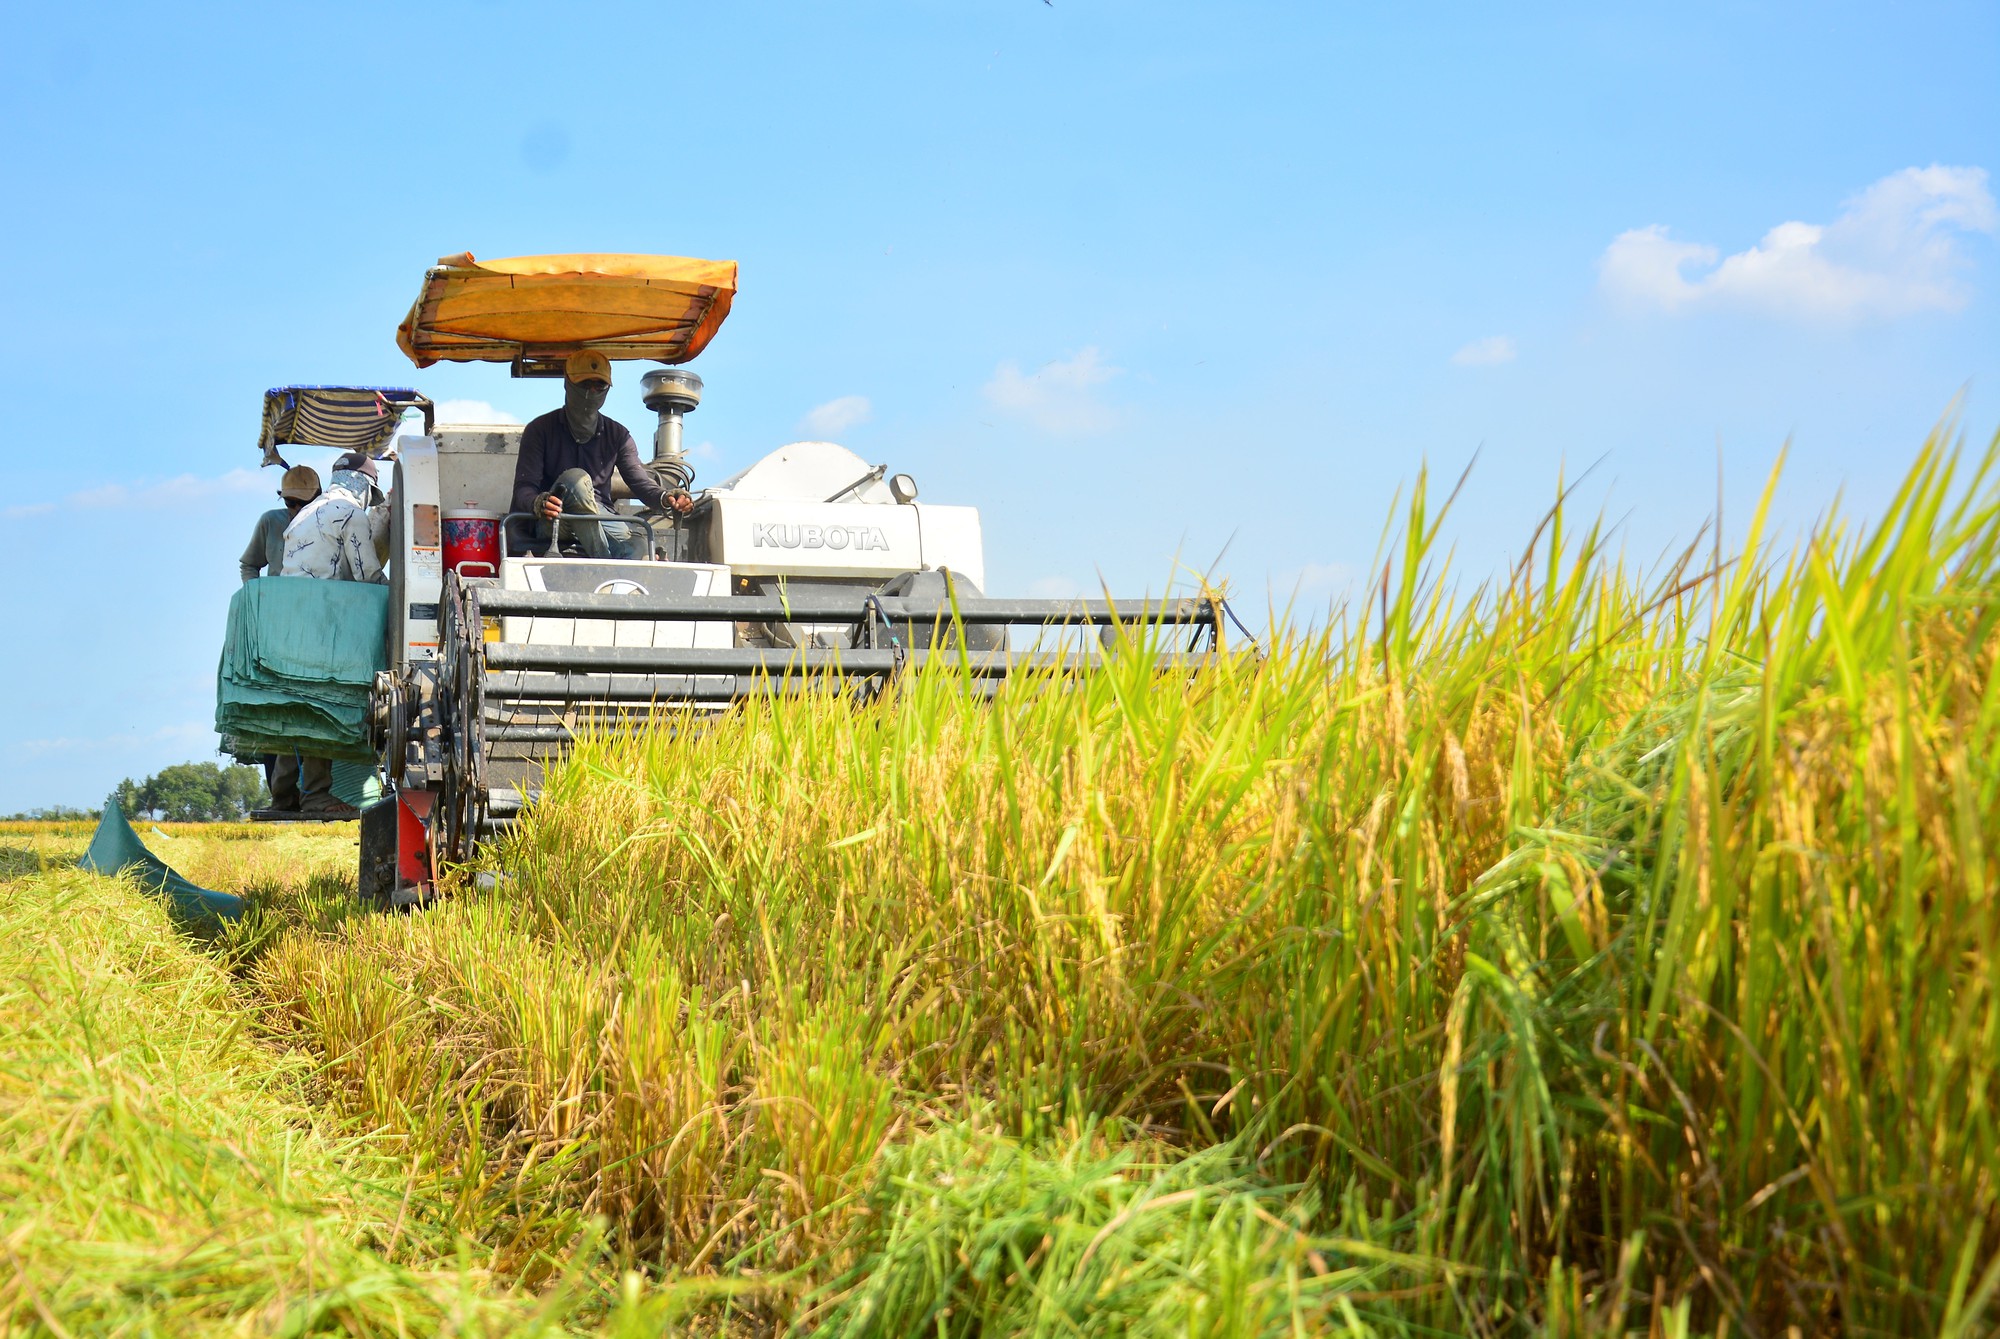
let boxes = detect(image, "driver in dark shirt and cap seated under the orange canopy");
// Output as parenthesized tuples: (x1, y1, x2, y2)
(514, 350, 694, 558)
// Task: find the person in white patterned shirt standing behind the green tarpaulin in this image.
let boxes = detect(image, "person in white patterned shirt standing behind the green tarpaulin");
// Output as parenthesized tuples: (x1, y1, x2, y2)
(270, 452, 388, 821)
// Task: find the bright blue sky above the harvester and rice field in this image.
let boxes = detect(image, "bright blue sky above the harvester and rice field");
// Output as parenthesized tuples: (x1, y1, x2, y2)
(0, 0, 2000, 811)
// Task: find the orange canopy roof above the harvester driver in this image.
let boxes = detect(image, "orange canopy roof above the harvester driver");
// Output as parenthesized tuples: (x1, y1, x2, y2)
(396, 252, 736, 368)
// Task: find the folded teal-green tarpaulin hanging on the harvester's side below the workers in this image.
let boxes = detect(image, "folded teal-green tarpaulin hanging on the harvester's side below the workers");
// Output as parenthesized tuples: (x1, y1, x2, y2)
(216, 576, 388, 761)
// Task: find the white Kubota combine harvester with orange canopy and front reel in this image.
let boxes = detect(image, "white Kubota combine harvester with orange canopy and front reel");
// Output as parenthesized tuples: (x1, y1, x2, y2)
(250, 254, 1222, 905)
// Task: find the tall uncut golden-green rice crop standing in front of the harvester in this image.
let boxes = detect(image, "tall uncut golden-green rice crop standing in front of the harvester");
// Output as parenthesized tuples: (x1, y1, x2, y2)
(0, 432, 2000, 1337)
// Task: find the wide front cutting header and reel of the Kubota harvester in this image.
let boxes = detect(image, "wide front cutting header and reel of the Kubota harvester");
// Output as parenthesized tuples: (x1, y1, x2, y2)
(362, 572, 1228, 905)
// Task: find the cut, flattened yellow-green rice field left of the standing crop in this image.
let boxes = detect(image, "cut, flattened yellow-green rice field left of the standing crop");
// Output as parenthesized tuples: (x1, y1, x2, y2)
(0, 823, 630, 1335)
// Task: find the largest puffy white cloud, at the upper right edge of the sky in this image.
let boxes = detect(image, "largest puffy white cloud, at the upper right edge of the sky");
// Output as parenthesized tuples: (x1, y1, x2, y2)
(1598, 166, 2000, 322)
